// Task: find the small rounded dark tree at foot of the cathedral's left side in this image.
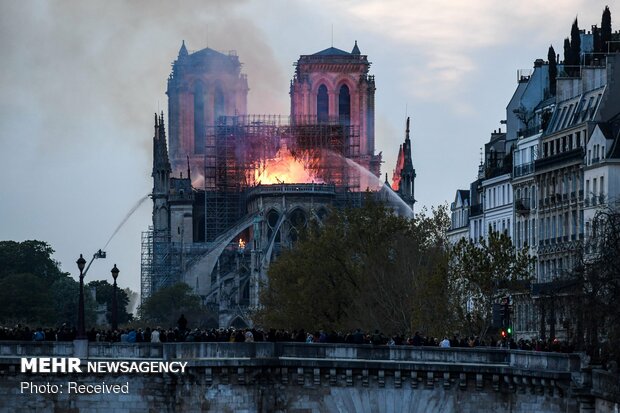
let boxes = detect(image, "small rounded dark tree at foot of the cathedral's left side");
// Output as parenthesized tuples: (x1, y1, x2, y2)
(138, 282, 209, 327)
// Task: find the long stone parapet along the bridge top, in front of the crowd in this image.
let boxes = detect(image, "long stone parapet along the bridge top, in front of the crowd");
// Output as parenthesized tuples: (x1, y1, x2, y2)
(0, 341, 582, 373)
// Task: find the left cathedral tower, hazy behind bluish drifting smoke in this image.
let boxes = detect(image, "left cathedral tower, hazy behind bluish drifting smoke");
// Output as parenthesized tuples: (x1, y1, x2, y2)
(166, 42, 248, 176)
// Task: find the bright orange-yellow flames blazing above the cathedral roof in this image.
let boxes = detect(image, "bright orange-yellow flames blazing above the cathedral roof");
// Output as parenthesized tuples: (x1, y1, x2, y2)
(254, 146, 323, 185)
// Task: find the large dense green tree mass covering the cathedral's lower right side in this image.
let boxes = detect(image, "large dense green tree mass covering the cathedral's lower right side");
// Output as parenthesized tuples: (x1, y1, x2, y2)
(255, 200, 449, 333)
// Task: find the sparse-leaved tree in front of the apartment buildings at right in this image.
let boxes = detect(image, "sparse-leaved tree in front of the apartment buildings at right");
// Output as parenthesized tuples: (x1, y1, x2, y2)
(450, 231, 533, 336)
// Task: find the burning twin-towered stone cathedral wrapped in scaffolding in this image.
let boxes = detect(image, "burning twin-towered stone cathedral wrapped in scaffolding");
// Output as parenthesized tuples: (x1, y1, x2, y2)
(141, 42, 415, 327)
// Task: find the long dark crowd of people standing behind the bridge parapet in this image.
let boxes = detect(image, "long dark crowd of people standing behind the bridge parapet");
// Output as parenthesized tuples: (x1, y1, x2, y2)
(0, 316, 573, 353)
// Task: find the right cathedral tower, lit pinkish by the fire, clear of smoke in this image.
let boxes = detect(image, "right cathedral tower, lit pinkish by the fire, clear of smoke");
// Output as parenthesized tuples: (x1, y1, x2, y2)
(290, 41, 381, 176)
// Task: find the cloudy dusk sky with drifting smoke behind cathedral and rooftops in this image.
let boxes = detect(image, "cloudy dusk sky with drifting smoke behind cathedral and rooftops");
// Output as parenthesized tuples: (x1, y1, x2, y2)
(0, 0, 620, 292)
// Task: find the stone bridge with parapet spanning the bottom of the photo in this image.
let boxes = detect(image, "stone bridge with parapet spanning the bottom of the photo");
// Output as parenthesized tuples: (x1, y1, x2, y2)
(0, 342, 620, 413)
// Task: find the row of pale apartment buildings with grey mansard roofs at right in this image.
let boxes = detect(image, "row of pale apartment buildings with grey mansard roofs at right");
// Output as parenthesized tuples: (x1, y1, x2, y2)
(449, 29, 620, 341)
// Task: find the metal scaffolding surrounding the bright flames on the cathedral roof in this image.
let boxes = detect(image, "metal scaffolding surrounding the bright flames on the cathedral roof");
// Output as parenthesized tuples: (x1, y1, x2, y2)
(201, 115, 362, 242)
